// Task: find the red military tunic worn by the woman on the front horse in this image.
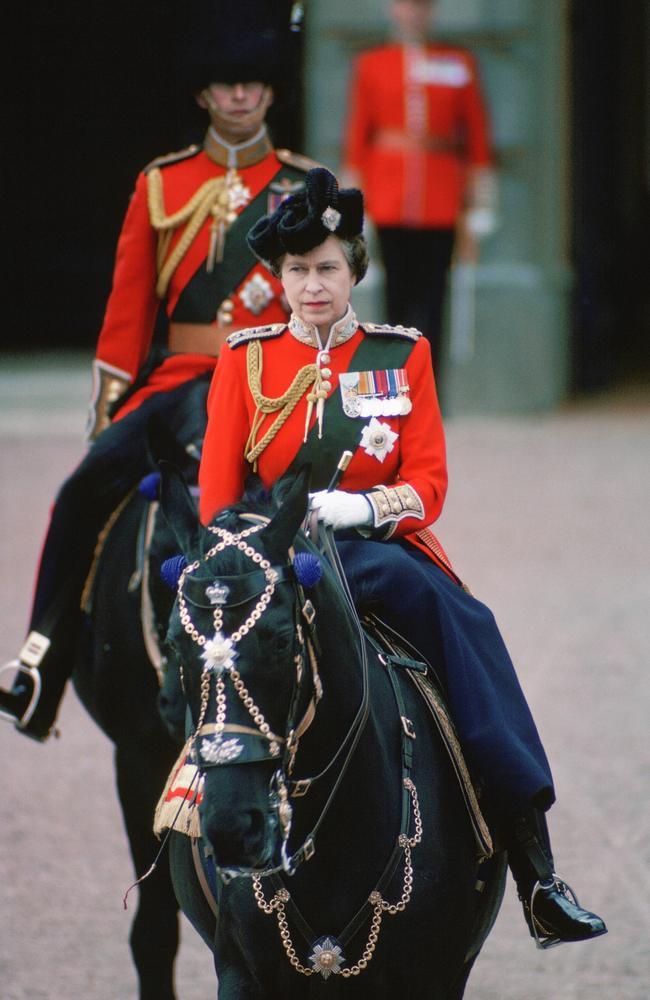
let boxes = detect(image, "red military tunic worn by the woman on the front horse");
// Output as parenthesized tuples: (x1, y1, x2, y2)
(199, 311, 447, 572)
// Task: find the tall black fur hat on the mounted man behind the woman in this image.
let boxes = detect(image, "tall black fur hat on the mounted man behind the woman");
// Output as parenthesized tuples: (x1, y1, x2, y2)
(173, 0, 295, 94)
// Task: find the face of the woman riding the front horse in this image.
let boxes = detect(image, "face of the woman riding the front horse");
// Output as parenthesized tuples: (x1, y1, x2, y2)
(280, 236, 354, 333)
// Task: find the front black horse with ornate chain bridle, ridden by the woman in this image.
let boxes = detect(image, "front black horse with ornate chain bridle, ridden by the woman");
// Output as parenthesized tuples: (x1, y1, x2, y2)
(162, 471, 504, 1000)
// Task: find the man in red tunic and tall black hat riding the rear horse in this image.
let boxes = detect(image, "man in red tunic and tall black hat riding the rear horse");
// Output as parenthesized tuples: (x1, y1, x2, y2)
(0, 2, 314, 740)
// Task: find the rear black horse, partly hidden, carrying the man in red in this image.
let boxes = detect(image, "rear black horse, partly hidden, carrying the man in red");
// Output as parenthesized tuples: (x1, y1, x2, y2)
(72, 462, 190, 1000)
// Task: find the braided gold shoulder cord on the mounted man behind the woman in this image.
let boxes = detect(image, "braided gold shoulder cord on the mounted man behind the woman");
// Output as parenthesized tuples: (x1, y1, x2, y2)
(147, 167, 242, 299)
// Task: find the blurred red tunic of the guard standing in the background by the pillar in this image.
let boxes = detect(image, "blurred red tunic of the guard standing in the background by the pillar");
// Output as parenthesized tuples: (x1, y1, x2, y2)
(345, 44, 491, 228)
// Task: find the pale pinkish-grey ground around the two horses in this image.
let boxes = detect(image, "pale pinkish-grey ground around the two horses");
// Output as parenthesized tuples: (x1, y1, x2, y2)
(0, 357, 650, 1000)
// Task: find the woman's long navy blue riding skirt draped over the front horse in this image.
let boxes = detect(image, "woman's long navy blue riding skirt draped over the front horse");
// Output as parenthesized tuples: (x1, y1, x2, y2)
(337, 540, 555, 811)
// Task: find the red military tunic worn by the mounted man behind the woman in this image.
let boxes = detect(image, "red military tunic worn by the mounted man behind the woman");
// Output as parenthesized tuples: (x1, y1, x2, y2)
(90, 133, 314, 417)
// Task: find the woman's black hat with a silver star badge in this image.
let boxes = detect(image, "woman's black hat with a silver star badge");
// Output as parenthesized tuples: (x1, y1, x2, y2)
(246, 167, 363, 261)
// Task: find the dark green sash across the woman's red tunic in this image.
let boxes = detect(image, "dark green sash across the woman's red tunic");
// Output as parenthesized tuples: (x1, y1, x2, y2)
(283, 333, 415, 490)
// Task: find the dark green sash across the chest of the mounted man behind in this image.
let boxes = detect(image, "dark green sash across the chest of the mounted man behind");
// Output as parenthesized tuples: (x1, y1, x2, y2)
(171, 165, 305, 323)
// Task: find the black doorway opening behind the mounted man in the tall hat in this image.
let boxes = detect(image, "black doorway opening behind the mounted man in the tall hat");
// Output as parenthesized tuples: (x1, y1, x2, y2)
(1, 0, 302, 351)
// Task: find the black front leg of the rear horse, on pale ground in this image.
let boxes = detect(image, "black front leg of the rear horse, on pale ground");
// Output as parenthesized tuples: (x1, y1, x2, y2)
(115, 738, 179, 1000)
